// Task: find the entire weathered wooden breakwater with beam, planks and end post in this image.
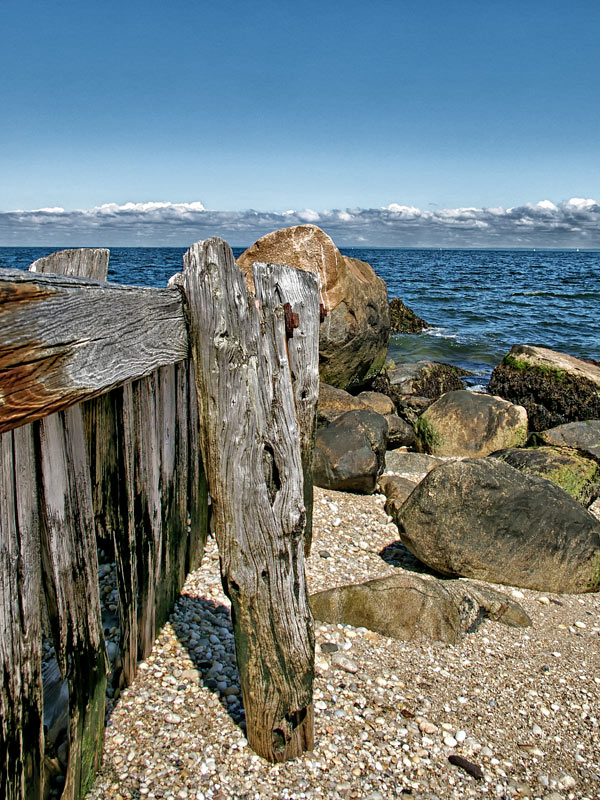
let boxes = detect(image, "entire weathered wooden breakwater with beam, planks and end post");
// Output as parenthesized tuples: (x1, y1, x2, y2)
(0, 239, 319, 798)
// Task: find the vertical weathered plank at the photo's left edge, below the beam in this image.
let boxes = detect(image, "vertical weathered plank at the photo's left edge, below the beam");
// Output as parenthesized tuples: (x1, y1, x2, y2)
(0, 425, 44, 800)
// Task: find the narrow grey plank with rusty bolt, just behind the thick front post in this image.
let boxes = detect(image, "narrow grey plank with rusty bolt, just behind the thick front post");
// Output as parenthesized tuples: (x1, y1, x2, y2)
(253, 262, 320, 558)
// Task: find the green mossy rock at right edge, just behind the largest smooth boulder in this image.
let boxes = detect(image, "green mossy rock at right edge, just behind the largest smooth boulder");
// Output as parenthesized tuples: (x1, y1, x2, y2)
(493, 447, 600, 506)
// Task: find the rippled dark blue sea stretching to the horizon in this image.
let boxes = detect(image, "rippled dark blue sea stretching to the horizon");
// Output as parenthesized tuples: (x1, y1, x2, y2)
(0, 247, 600, 386)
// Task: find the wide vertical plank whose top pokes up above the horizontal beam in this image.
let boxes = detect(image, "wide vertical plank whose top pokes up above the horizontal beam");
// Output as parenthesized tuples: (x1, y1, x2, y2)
(30, 250, 108, 800)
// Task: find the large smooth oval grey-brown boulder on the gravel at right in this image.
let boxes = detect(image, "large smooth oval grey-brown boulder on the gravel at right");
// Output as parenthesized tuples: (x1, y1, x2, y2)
(393, 458, 600, 592)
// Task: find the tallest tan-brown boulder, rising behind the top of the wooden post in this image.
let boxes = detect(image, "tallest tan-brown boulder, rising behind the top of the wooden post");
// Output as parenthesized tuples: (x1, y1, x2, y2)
(237, 225, 390, 389)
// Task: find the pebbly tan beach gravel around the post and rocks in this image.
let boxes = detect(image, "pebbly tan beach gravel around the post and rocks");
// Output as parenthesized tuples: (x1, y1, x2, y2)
(88, 489, 600, 800)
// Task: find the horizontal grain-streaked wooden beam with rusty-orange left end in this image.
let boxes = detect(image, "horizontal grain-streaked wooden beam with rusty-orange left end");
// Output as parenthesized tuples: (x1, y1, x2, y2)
(0, 269, 189, 433)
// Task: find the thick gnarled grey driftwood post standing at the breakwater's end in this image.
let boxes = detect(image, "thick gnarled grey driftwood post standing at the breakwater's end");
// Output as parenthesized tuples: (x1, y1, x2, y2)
(181, 239, 319, 761)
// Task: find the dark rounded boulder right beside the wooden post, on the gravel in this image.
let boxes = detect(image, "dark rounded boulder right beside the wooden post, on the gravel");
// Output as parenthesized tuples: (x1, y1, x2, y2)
(313, 409, 388, 494)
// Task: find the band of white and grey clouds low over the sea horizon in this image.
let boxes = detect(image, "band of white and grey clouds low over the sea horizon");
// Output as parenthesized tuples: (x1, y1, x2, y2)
(0, 197, 600, 248)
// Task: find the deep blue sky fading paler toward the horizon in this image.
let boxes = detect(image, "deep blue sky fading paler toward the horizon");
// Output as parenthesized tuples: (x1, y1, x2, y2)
(0, 0, 600, 246)
